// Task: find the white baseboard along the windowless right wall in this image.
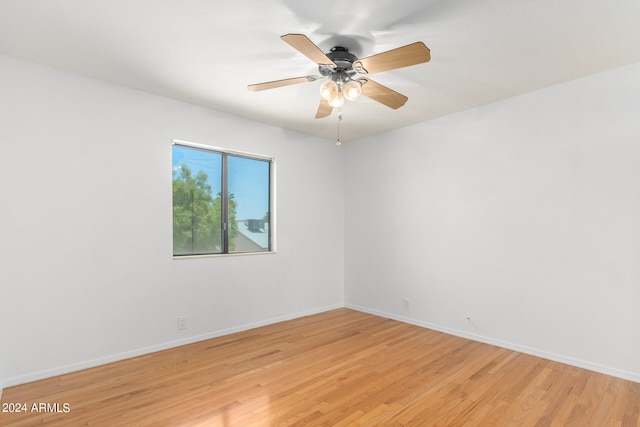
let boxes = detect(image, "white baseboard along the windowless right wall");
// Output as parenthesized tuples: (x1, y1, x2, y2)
(345, 304, 640, 383)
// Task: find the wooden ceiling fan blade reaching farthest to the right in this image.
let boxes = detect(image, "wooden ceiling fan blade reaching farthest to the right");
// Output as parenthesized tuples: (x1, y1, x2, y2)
(353, 42, 431, 74)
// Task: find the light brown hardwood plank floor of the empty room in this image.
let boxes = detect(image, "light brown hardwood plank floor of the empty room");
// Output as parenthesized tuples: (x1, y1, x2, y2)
(0, 309, 640, 427)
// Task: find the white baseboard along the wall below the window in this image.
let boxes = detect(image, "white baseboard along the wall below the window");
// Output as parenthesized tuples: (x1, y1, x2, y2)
(0, 304, 344, 397)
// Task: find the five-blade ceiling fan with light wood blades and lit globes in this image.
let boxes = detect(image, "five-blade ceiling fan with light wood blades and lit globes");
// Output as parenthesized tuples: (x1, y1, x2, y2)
(247, 34, 431, 119)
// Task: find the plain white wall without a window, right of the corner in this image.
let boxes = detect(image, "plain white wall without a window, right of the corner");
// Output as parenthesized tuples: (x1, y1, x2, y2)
(345, 64, 640, 381)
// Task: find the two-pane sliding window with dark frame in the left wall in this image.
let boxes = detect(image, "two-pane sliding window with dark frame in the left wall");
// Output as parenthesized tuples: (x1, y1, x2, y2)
(172, 141, 273, 256)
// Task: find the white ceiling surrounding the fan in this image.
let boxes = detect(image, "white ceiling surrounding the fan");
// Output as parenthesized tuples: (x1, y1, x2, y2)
(0, 0, 640, 141)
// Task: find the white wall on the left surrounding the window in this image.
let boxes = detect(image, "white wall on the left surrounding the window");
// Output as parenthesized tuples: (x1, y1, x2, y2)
(0, 56, 344, 387)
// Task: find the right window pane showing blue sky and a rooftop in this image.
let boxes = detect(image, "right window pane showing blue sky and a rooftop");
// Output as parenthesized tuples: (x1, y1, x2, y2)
(227, 156, 270, 252)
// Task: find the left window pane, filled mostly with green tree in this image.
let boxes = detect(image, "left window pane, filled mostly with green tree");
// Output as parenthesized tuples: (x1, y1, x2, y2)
(172, 145, 222, 255)
